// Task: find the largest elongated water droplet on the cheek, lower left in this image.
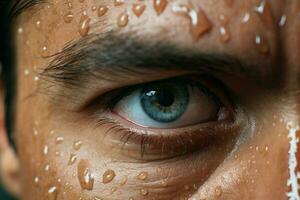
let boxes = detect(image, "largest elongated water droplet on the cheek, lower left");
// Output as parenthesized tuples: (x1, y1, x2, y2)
(77, 160, 94, 190)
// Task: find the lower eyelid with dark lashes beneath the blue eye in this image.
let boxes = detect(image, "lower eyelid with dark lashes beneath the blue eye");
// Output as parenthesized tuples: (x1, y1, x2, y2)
(95, 113, 240, 161)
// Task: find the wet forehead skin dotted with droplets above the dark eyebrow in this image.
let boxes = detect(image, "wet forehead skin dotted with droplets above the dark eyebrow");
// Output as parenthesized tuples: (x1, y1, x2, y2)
(15, 0, 300, 74)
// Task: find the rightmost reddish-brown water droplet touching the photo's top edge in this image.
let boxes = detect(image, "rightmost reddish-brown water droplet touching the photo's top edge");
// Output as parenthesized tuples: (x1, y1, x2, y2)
(255, 1, 273, 26)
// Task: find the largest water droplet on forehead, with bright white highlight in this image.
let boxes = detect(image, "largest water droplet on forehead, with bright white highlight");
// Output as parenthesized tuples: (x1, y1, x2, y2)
(173, 5, 212, 41)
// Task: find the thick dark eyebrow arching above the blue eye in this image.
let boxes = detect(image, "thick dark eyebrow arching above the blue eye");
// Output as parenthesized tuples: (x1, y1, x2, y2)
(40, 31, 278, 92)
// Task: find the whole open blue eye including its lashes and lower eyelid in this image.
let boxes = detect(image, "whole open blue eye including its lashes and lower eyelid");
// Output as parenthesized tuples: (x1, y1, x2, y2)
(86, 76, 237, 161)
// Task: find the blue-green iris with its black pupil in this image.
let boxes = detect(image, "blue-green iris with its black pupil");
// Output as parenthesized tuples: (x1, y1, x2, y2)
(140, 82, 189, 123)
